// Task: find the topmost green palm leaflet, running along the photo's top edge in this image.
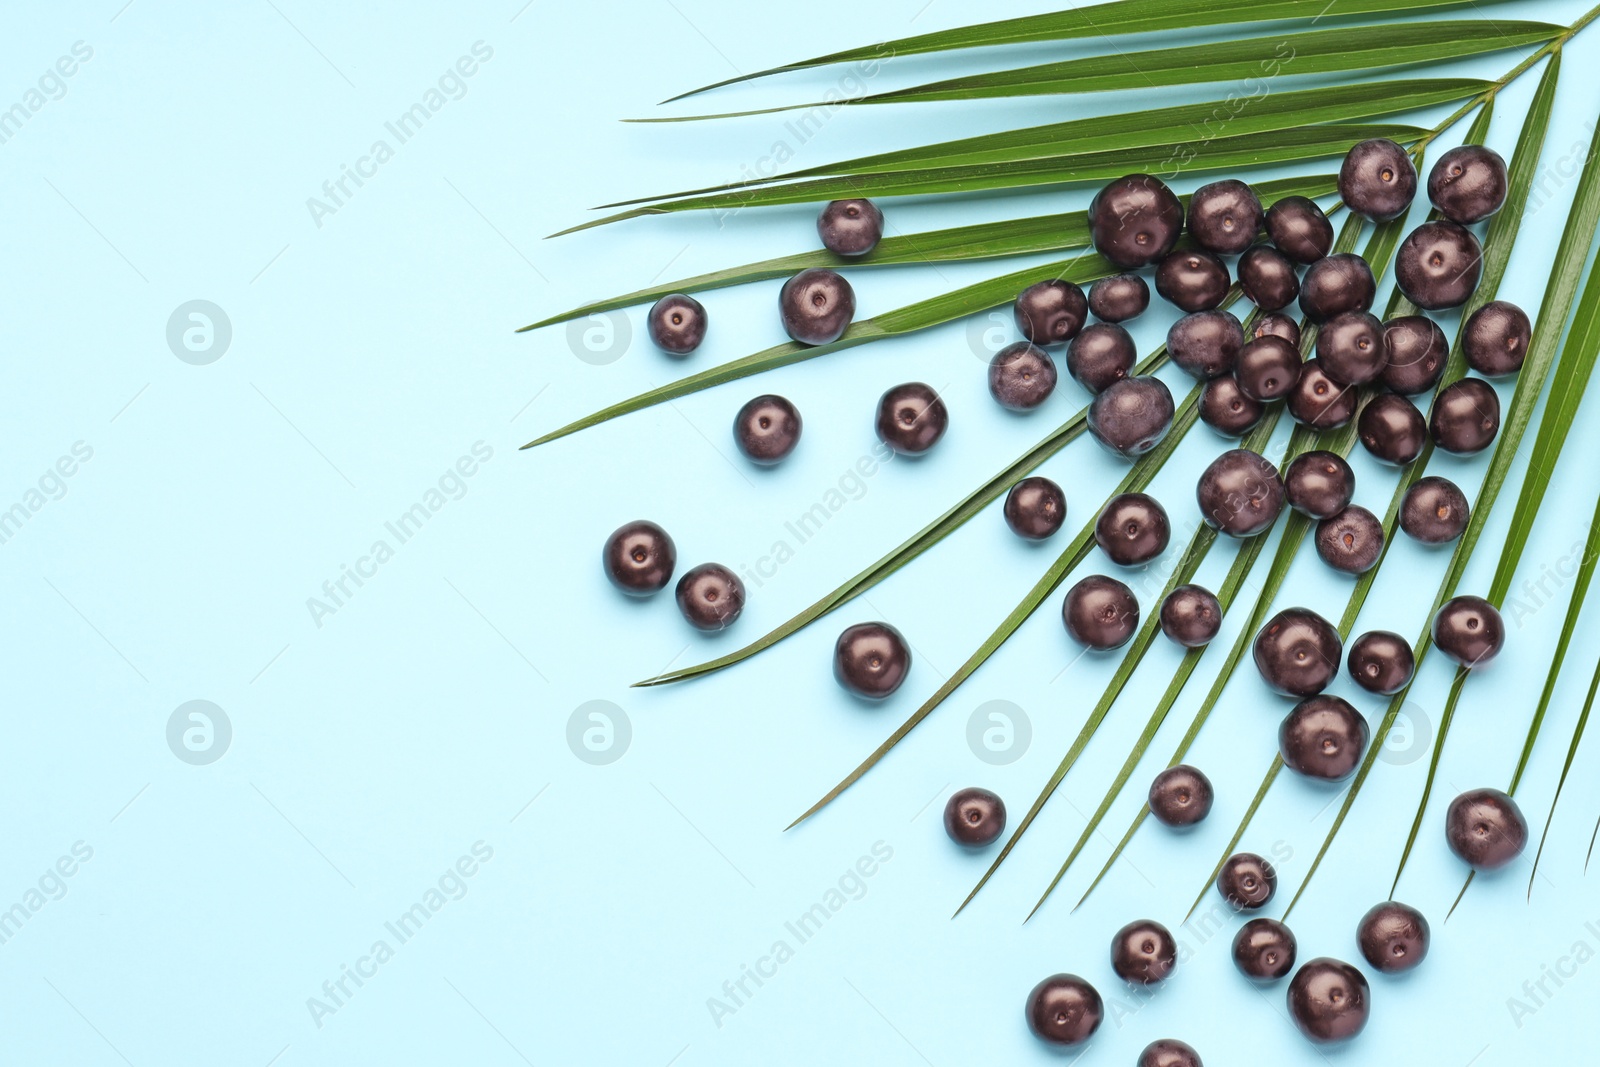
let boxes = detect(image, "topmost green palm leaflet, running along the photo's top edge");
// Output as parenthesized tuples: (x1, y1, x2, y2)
(662, 0, 1516, 104)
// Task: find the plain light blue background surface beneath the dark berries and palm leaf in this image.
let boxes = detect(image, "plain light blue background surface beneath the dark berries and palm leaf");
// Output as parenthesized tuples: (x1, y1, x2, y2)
(0, 0, 1600, 1067)
